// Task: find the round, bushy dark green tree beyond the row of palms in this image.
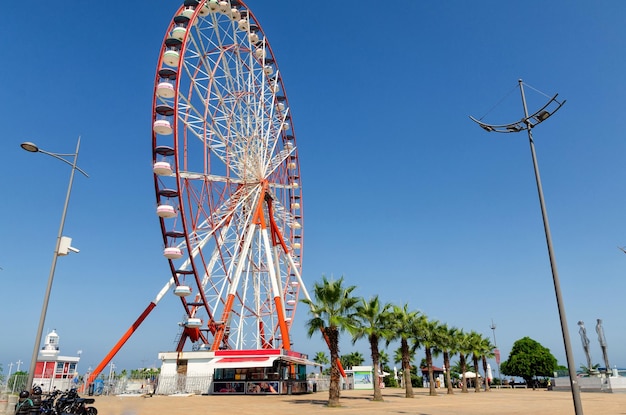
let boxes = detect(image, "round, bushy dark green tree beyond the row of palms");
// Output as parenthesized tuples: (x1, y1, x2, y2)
(500, 337, 557, 385)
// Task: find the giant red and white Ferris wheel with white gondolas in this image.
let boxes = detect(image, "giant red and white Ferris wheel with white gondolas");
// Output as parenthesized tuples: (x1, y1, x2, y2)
(152, 0, 306, 351)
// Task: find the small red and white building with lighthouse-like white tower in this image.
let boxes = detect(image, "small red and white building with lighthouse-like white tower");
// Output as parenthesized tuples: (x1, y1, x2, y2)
(33, 330, 80, 392)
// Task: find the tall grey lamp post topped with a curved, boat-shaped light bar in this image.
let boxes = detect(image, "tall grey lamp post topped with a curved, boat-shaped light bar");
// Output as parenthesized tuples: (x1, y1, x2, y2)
(470, 79, 583, 415)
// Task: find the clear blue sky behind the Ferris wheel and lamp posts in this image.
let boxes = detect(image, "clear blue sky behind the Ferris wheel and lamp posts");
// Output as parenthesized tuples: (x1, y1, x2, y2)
(0, 0, 626, 374)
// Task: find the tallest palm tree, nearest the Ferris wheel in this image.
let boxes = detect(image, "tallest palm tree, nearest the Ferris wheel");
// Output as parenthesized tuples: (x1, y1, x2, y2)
(302, 276, 358, 407)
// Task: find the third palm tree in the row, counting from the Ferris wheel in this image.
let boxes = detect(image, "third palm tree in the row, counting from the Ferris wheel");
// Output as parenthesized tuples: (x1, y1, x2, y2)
(386, 304, 421, 398)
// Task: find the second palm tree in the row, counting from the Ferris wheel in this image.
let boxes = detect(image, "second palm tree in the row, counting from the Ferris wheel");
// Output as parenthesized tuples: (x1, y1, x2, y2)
(352, 295, 391, 401)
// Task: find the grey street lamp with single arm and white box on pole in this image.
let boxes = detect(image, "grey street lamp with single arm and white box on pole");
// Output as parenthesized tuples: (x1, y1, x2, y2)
(20, 137, 89, 390)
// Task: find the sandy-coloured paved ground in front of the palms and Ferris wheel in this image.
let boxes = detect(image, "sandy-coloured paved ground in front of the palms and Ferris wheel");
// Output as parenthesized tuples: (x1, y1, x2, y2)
(85, 388, 626, 415)
